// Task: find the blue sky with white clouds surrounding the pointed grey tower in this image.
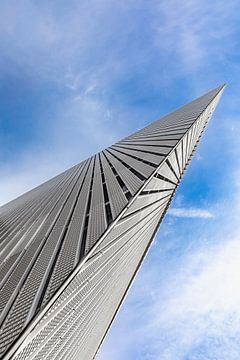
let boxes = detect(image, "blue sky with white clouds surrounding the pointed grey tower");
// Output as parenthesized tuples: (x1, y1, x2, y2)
(0, 0, 240, 360)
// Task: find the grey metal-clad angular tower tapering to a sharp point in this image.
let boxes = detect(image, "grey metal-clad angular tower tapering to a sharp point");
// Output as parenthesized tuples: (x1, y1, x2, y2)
(0, 86, 224, 360)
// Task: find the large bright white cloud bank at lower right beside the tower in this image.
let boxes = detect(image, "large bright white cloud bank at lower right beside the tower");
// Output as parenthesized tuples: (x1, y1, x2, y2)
(146, 239, 240, 360)
